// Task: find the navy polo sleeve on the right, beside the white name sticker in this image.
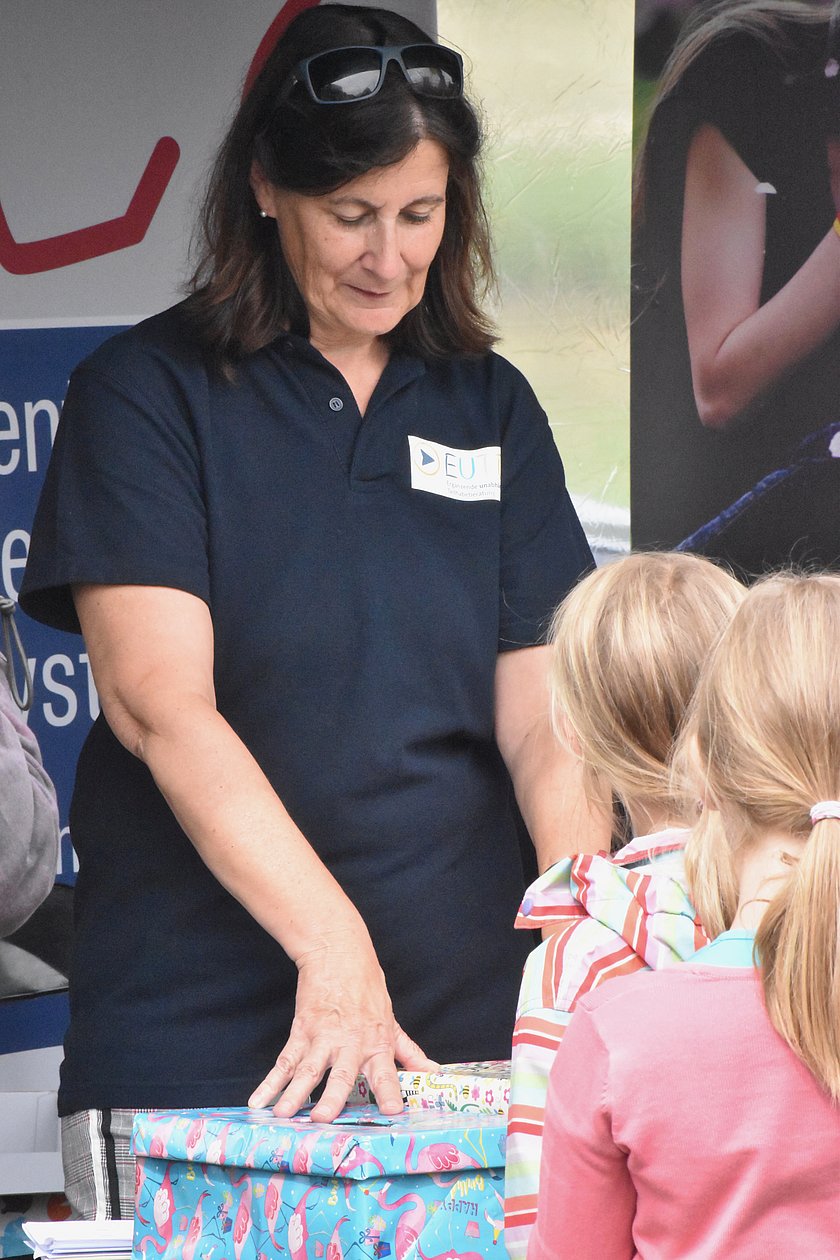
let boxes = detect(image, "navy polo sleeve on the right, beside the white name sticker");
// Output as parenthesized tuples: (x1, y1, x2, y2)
(499, 365, 594, 651)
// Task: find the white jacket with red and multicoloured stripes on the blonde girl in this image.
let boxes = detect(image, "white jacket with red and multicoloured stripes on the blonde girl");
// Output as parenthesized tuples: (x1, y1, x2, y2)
(505, 828, 708, 1260)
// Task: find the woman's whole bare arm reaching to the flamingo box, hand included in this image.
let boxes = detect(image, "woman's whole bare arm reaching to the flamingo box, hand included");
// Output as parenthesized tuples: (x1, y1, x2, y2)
(74, 586, 436, 1120)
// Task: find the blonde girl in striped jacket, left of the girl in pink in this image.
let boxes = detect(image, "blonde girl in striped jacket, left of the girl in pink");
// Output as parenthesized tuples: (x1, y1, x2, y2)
(505, 553, 744, 1260)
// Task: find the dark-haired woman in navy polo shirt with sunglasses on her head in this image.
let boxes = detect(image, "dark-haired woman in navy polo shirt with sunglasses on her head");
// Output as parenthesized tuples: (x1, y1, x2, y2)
(21, 5, 597, 1215)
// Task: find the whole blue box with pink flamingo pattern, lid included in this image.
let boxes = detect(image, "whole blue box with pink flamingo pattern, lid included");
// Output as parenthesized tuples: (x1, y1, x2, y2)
(133, 1106, 508, 1260)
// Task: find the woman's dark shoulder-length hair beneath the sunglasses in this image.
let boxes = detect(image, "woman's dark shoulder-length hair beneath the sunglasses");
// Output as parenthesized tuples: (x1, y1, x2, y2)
(189, 4, 495, 370)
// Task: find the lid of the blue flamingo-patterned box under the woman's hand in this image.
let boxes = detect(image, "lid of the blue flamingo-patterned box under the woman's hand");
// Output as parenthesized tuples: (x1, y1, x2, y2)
(133, 1106, 505, 1181)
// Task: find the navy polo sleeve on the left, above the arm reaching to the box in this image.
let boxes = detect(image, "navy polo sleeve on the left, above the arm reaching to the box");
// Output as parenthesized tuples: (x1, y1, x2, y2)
(20, 355, 209, 630)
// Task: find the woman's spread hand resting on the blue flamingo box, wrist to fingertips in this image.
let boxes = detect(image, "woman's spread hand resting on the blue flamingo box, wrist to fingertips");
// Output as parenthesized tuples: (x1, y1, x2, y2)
(248, 927, 440, 1123)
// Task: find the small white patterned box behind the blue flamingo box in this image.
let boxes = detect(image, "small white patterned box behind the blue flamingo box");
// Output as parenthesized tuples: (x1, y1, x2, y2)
(349, 1058, 510, 1115)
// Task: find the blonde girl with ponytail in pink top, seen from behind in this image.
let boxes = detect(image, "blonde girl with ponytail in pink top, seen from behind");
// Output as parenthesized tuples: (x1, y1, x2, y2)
(528, 575, 840, 1260)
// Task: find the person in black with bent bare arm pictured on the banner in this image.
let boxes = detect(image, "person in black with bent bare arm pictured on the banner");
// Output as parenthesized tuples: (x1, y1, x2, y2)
(631, 0, 840, 573)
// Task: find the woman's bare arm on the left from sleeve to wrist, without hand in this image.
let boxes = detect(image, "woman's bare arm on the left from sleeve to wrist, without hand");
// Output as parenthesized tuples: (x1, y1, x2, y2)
(74, 586, 373, 961)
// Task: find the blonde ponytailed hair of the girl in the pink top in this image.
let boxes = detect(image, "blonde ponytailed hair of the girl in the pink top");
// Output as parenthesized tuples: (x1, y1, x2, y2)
(679, 573, 840, 1100)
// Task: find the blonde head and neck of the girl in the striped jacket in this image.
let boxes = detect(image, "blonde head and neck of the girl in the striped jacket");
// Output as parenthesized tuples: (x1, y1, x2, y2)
(550, 552, 743, 837)
